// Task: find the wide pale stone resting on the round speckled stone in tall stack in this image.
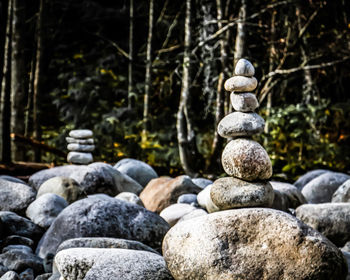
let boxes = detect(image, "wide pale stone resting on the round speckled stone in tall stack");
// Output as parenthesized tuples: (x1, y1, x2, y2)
(218, 112, 265, 138)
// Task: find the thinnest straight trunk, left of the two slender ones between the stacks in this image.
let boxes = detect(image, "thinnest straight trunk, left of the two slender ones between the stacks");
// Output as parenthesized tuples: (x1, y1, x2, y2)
(128, 0, 135, 109)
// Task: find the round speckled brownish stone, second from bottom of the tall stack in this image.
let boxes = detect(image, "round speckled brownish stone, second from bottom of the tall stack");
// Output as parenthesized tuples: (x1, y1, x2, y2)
(221, 139, 272, 181)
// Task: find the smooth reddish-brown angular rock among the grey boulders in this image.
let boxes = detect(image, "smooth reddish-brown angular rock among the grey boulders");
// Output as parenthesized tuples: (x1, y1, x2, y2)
(140, 175, 202, 213)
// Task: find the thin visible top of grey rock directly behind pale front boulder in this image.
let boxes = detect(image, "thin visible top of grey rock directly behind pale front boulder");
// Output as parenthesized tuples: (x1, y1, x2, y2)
(56, 237, 159, 254)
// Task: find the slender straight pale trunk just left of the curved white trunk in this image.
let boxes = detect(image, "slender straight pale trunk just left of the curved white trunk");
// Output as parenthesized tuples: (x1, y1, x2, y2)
(142, 0, 154, 142)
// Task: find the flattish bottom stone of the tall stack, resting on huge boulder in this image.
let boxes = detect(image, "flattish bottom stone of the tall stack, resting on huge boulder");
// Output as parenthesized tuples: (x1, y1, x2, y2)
(210, 177, 274, 210)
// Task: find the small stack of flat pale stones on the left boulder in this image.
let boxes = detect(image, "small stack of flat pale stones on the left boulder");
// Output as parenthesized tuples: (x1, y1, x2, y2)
(66, 129, 95, 164)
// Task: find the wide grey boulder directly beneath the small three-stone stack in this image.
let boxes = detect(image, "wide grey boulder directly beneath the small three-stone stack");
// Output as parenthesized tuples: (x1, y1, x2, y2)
(70, 162, 143, 196)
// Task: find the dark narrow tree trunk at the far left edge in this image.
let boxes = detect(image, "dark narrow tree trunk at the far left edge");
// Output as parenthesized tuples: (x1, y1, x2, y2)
(0, 0, 13, 163)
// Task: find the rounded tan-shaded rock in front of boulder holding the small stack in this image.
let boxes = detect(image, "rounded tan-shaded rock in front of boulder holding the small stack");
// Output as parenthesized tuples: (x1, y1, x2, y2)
(36, 177, 86, 203)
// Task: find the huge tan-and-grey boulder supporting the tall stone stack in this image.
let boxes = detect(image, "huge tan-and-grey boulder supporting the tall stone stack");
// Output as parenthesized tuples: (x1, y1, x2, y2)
(163, 208, 347, 280)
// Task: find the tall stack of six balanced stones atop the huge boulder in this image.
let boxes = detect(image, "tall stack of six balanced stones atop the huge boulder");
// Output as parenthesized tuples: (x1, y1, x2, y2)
(210, 59, 274, 210)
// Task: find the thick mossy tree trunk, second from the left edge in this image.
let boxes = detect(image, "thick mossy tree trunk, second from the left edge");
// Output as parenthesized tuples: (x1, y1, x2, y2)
(11, 0, 27, 161)
